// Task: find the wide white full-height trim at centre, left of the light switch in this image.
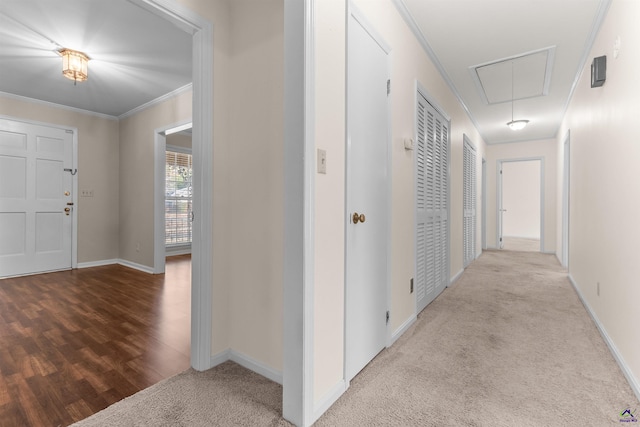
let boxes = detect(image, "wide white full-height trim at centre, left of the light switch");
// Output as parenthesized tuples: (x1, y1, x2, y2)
(282, 0, 321, 426)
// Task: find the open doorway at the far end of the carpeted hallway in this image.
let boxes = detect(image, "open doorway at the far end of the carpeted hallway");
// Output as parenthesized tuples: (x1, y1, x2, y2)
(498, 158, 544, 252)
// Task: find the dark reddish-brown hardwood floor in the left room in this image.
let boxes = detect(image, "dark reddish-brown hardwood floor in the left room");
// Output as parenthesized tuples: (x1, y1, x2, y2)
(0, 255, 191, 427)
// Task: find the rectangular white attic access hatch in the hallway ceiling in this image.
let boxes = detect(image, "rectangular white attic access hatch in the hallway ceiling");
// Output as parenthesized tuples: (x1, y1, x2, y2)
(469, 46, 556, 105)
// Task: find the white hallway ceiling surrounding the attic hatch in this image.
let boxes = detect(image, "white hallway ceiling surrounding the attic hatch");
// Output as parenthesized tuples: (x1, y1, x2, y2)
(396, 0, 613, 144)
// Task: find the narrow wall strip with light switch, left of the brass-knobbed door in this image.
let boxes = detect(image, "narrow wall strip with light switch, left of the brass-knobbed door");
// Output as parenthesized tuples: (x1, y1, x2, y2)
(313, 0, 346, 402)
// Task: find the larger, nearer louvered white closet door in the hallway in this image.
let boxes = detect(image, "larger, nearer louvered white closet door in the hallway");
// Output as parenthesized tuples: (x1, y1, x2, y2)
(415, 93, 449, 312)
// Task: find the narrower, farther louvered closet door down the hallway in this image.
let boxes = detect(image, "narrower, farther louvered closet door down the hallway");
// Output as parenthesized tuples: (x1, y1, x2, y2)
(462, 137, 476, 267)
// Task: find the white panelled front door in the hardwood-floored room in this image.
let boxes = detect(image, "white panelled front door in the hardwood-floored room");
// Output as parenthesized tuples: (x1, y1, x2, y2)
(0, 118, 74, 277)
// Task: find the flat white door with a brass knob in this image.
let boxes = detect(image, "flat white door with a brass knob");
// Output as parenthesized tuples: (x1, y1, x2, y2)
(346, 9, 388, 380)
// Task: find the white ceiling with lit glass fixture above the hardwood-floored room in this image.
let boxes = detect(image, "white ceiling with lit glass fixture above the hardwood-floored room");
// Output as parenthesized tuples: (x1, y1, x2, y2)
(0, 0, 192, 117)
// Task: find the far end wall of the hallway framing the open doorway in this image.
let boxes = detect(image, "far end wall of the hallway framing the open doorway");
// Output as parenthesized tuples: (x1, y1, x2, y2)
(486, 139, 558, 253)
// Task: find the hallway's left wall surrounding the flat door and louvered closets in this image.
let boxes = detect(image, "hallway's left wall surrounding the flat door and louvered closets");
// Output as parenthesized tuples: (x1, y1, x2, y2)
(313, 0, 484, 403)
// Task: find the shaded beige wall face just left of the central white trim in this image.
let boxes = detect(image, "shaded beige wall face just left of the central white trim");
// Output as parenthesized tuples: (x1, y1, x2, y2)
(226, 0, 284, 371)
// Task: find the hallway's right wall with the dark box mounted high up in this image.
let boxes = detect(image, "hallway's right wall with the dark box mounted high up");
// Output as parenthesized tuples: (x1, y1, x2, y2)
(556, 0, 640, 397)
